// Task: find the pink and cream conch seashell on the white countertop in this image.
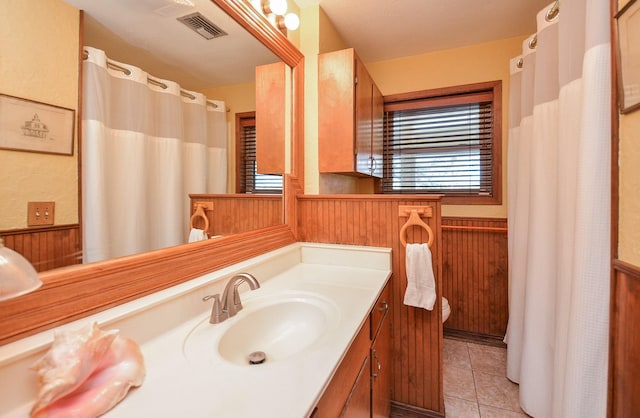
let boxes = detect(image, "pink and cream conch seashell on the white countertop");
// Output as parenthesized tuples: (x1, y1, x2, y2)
(31, 323, 145, 418)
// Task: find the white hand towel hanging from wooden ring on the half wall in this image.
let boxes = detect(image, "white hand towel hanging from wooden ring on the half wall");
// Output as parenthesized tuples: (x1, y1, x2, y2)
(404, 244, 436, 311)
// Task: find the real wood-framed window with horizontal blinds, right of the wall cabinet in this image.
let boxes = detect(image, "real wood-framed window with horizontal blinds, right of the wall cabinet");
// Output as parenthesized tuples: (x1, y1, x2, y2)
(382, 81, 502, 204)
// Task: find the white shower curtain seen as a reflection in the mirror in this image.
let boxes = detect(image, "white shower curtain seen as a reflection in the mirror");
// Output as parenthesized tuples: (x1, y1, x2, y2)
(82, 47, 227, 262)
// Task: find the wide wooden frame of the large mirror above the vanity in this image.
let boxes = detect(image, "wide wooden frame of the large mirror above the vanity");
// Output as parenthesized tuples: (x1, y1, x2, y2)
(0, 0, 304, 345)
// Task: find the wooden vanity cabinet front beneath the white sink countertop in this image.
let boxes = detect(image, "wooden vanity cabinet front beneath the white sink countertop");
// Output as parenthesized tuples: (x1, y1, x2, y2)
(312, 284, 392, 418)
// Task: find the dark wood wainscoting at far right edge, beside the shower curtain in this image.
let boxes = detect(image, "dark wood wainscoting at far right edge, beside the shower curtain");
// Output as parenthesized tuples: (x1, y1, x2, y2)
(608, 260, 640, 418)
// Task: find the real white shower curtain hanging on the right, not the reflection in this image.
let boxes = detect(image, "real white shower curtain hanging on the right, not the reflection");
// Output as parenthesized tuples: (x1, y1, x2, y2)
(505, 0, 611, 418)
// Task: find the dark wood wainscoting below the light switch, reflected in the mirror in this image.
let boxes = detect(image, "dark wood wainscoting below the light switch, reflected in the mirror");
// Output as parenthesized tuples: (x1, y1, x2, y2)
(0, 224, 82, 271)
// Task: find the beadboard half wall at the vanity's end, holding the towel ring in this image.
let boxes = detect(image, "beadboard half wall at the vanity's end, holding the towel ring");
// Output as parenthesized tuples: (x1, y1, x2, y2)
(297, 195, 444, 414)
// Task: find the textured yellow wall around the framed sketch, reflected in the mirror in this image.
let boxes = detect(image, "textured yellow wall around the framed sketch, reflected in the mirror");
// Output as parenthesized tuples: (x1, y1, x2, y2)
(0, 0, 80, 230)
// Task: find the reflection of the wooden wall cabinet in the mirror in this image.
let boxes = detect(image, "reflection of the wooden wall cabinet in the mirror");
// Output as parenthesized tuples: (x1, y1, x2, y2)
(256, 62, 291, 174)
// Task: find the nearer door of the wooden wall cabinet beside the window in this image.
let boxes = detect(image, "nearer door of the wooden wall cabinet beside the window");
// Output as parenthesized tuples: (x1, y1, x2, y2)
(355, 59, 373, 175)
